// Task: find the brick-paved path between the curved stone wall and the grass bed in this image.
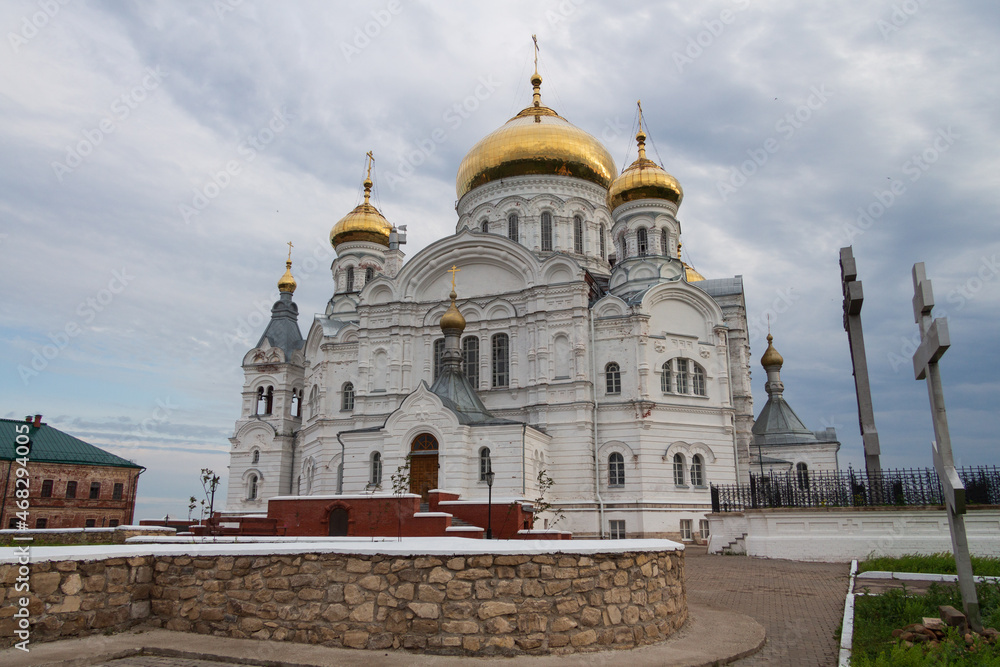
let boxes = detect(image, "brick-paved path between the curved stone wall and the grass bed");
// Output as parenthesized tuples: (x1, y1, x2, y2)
(684, 547, 850, 667)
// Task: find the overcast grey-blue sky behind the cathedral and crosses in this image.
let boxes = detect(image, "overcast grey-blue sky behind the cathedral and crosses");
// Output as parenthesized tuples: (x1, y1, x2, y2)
(0, 0, 1000, 519)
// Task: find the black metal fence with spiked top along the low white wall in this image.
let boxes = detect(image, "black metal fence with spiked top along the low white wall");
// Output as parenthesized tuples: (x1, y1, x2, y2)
(712, 466, 1000, 512)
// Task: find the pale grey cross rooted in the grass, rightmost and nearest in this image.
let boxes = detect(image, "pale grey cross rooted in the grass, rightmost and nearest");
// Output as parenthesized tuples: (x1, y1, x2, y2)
(913, 262, 983, 632)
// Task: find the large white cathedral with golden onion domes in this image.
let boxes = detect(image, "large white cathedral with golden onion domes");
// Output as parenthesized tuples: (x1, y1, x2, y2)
(227, 72, 839, 539)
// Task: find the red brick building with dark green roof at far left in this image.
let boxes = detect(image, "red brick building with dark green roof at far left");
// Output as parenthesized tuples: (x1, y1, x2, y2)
(0, 415, 145, 528)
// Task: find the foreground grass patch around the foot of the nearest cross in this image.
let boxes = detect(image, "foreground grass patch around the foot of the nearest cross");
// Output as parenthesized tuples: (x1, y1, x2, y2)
(851, 583, 1000, 667)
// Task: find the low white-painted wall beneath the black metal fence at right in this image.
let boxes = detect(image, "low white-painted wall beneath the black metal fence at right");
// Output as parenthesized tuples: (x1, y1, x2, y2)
(708, 507, 1000, 563)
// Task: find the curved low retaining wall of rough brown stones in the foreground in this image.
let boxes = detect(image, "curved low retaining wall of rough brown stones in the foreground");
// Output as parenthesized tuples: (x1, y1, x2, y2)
(0, 551, 687, 655)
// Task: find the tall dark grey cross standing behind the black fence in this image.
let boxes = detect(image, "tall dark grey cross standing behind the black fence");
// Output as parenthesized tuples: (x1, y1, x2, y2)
(840, 246, 882, 477)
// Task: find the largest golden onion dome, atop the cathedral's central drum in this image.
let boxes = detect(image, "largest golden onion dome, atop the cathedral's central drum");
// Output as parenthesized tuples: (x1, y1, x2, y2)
(455, 72, 618, 199)
